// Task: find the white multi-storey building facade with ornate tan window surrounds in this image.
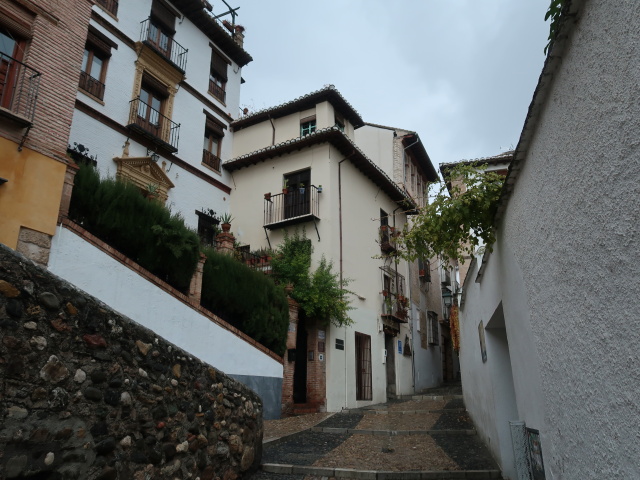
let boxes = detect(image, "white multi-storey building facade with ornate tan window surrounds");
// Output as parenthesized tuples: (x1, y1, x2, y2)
(69, 0, 251, 229)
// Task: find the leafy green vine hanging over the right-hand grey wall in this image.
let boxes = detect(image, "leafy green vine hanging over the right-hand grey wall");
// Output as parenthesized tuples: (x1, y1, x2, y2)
(398, 163, 504, 262)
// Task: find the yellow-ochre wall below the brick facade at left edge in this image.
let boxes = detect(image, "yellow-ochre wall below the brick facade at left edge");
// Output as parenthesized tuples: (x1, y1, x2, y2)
(0, 138, 66, 249)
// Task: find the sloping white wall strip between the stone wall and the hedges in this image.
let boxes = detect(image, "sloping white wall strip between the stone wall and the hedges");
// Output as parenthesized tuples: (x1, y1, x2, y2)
(49, 227, 282, 378)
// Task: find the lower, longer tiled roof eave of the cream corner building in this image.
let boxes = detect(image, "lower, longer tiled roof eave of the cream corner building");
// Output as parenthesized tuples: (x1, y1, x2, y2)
(222, 127, 415, 208)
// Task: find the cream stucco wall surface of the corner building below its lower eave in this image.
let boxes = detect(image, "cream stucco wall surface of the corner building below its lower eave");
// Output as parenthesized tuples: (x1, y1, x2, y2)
(231, 140, 411, 411)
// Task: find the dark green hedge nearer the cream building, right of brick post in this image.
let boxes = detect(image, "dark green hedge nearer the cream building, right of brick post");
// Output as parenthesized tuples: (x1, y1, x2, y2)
(201, 247, 289, 355)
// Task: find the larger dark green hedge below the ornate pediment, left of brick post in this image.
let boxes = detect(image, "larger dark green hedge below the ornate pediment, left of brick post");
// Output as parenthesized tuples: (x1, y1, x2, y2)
(69, 165, 200, 292)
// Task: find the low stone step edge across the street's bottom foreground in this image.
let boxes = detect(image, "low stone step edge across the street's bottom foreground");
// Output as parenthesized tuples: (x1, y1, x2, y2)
(261, 463, 502, 480)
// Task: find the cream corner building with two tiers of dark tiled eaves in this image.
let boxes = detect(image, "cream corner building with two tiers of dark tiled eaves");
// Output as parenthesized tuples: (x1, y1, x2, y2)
(223, 86, 415, 411)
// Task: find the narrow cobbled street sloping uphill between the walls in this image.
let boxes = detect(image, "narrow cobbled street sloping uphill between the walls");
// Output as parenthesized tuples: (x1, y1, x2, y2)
(251, 386, 502, 480)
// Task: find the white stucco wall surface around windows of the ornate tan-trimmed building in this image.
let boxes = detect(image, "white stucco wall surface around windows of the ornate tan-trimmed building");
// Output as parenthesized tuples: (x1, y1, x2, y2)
(69, 0, 242, 228)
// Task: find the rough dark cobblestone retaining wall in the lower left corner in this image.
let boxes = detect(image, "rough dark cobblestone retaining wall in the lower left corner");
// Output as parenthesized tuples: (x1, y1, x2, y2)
(0, 245, 263, 480)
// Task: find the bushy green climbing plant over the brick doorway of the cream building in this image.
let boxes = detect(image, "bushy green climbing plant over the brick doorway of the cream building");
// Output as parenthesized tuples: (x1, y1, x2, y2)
(271, 231, 353, 327)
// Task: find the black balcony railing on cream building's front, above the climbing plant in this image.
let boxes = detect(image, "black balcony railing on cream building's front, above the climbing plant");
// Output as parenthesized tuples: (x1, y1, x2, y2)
(264, 185, 320, 228)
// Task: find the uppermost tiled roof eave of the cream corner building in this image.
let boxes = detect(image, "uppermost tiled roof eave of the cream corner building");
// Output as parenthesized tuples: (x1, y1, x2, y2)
(231, 85, 364, 131)
